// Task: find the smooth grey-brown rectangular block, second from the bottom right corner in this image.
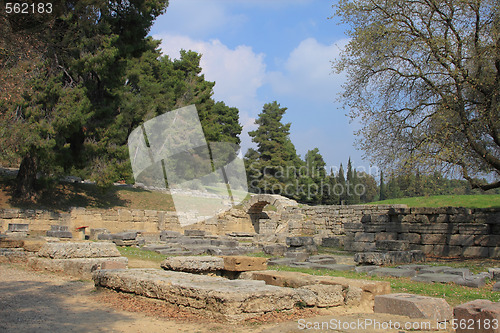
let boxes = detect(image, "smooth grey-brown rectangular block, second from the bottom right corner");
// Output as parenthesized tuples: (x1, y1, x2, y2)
(374, 293, 453, 322)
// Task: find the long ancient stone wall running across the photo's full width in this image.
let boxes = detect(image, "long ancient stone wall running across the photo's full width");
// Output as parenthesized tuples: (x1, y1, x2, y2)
(0, 205, 500, 258)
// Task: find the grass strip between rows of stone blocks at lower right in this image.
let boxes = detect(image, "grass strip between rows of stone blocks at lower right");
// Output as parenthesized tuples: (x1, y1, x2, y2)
(272, 266, 500, 307)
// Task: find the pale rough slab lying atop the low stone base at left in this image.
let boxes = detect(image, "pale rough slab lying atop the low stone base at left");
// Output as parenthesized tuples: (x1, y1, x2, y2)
(38, 242, 120, 259)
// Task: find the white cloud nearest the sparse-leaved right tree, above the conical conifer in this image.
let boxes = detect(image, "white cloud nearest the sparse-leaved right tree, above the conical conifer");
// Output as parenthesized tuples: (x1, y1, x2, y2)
(268, 38, 348, 102)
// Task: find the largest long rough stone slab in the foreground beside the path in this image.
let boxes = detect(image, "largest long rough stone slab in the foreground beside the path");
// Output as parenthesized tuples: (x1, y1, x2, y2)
(93, 269, 300, 321)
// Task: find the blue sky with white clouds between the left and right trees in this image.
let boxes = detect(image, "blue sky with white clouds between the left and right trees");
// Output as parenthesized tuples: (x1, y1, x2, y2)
(150, 0, 376, 175)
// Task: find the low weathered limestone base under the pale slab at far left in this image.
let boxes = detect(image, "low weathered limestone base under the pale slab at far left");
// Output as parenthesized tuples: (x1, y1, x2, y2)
(28, 257, 128, 279)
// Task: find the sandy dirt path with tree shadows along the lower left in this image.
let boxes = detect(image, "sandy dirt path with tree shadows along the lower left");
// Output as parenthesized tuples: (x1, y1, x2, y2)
(0, 262, 454, 333)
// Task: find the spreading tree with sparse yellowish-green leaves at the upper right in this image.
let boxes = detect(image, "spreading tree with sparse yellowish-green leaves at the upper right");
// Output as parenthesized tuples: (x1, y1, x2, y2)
(336, 0, 500, 190)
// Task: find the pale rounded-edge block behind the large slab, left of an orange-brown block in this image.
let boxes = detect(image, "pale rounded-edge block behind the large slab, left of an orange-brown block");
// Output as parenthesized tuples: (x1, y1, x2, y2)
(160, 256, 224, 273)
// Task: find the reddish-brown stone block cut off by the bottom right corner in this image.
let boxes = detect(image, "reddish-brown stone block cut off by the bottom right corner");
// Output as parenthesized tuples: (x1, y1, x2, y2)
(453, 299, 500, 333)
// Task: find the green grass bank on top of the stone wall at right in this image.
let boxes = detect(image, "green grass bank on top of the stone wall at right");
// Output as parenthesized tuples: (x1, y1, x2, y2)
(367, 194, 500, 208)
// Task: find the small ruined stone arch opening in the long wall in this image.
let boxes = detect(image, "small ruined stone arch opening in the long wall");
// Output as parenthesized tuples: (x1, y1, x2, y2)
(243, 194, 297, 233)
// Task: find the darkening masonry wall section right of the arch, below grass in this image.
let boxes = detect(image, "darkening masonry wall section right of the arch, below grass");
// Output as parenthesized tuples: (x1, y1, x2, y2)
(275, 205, 500, 258)
